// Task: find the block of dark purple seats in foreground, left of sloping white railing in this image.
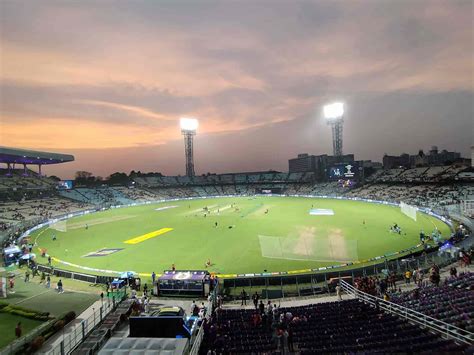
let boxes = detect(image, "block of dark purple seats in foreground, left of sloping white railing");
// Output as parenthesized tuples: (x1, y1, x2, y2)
(200, 300, 463, 354)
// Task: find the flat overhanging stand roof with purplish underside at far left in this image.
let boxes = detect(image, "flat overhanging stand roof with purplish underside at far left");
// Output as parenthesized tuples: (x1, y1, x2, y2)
(0, 147, 74, 165)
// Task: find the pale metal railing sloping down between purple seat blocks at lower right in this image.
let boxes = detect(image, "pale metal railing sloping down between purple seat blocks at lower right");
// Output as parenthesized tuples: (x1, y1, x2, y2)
(340, 280, 474, 345)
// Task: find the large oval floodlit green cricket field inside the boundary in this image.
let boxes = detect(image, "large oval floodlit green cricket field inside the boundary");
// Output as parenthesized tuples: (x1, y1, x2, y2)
(32, 197, 449, 274)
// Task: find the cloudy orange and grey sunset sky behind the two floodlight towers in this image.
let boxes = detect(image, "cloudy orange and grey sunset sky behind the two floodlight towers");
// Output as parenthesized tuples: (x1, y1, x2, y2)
(0, 0, 474, 177)
